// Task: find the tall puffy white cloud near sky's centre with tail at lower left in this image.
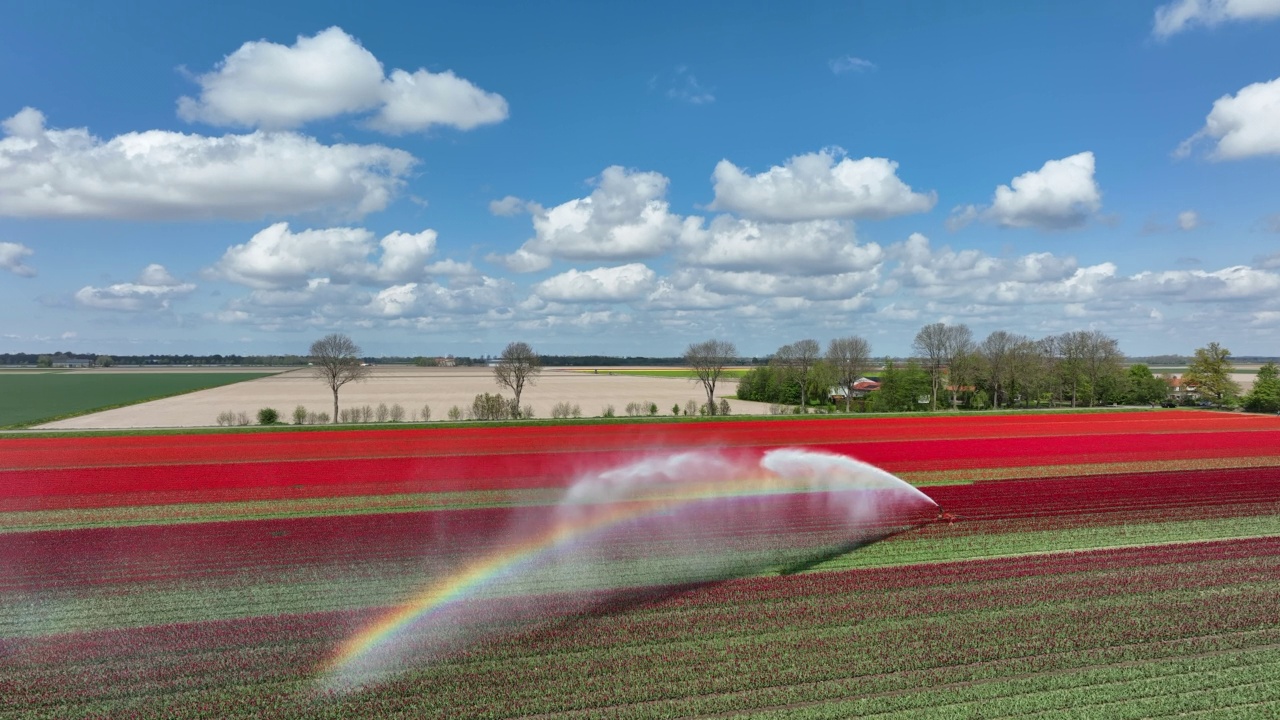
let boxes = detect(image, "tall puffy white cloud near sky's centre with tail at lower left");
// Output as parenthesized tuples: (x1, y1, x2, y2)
(489, 165, 684, 272)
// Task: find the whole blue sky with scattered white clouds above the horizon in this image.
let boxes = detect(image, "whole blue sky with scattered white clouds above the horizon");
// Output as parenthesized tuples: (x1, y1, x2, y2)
(0, 0, 1280, 355)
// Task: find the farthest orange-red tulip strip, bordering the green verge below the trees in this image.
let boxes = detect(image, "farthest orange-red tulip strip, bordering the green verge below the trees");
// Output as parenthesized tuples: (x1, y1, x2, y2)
(0, 410, 1280, 469)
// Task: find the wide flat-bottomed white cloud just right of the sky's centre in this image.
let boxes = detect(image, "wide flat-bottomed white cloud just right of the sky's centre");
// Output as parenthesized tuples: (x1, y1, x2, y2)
(710, 147, 937, 222)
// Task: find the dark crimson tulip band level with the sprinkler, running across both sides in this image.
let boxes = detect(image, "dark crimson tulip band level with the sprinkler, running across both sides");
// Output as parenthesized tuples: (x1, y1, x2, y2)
(10, 468, 1280, 587)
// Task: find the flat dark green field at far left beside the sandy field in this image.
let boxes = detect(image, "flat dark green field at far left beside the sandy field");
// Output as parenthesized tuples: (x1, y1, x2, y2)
(0, 372, 273, 427)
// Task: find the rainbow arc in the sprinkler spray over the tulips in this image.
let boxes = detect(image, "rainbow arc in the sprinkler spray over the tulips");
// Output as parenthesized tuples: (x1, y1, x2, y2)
(320, 451, 932, 676)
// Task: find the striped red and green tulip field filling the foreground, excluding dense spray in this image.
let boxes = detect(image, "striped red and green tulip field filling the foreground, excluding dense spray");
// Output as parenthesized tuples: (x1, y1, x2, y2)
(0, 410, 1280, 720)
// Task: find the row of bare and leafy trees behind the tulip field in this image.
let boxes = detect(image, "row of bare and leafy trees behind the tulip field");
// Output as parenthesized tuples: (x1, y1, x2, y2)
(311, 323, 1280, 423)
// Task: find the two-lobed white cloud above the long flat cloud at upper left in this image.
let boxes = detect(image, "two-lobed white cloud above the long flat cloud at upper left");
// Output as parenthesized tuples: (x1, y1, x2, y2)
(178, 27, 507, 135)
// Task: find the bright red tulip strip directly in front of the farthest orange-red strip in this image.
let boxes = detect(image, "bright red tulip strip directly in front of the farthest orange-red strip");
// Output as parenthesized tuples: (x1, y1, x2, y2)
(10, 430, 1280, 511)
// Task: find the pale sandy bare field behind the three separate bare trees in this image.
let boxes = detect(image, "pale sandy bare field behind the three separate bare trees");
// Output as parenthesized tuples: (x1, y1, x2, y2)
(40, 366, 769, 429)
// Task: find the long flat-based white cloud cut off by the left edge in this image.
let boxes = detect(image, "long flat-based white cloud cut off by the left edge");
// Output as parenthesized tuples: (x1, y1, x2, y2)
(0, 108, 416, 220)
